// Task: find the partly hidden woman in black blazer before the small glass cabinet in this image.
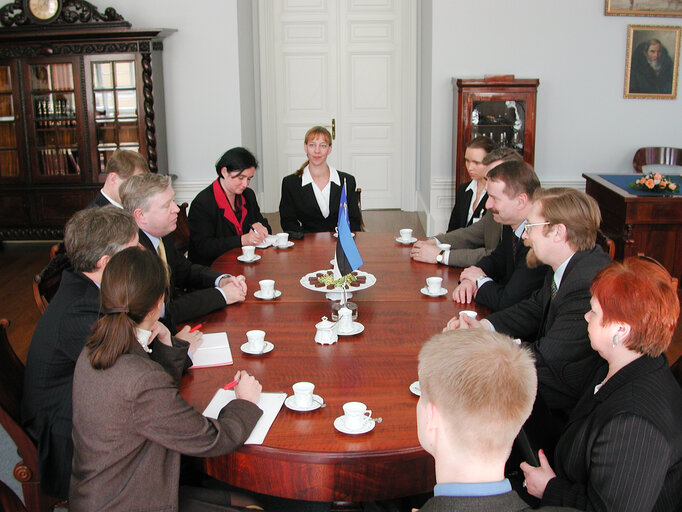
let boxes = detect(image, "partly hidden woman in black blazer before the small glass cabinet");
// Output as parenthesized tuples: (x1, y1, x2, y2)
(448, 135, 495, 233)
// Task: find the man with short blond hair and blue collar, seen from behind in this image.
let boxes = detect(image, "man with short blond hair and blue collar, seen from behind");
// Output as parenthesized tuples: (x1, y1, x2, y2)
(417, 329, 572, 512)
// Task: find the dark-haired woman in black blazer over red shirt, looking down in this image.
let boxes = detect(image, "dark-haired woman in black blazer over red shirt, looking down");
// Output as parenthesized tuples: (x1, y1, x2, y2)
(187, 148, 272, 266)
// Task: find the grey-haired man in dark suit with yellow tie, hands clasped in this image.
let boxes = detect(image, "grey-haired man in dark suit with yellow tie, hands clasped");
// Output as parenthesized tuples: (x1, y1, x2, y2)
(120, 173, 246, 332)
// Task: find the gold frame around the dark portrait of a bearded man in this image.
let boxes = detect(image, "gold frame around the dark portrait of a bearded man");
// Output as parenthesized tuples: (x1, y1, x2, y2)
(623, 25, 682, 100)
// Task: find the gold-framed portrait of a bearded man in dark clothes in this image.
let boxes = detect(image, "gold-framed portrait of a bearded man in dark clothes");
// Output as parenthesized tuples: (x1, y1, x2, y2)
(624, 25, 680, 100)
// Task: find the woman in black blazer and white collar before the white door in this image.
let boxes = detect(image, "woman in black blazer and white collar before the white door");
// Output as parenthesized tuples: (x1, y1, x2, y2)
(279, 126, 362, 233)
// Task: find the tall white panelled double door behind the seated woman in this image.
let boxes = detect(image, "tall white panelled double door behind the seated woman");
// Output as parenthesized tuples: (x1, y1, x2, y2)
(259, 0, 417, 211)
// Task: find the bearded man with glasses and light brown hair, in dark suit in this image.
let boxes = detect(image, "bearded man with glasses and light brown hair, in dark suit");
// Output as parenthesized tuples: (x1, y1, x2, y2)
(446, 188, 611, 447)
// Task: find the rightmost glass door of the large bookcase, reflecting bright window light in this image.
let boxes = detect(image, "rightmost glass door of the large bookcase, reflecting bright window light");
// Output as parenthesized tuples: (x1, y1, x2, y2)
(90, 59, 140, 173)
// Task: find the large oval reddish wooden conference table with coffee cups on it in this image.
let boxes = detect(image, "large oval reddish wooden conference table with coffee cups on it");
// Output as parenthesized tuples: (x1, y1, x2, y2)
(180, 233, 482, 502)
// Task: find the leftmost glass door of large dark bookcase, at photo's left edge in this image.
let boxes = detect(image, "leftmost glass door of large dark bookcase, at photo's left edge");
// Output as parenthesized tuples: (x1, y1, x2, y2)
(0, 63, 23, 182)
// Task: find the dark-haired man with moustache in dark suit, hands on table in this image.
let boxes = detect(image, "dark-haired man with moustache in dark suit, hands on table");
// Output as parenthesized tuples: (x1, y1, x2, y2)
(452, 161, 547, 311)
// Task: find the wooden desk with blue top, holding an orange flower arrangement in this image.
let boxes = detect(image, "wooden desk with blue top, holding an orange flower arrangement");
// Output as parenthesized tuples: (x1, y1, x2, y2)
(583, 174, 682, 281)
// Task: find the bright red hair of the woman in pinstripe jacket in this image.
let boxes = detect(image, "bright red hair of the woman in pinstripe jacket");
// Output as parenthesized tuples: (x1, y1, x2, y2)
(590, 258, 680, 357)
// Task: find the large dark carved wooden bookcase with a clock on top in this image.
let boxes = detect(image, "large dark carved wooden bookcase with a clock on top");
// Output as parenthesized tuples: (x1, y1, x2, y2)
(0, 0, 172, 241)
